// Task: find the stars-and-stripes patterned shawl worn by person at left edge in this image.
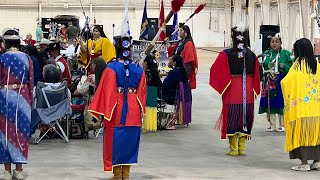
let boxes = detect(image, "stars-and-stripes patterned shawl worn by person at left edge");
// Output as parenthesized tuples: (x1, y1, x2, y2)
(0, 52, 33, 164)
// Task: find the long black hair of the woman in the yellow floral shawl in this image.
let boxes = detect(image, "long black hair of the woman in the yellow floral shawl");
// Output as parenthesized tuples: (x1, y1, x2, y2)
(293, 38, 317, 74)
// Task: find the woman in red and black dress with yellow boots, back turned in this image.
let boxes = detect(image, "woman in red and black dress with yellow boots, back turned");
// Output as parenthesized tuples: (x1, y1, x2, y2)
(209, 27, 260, 156)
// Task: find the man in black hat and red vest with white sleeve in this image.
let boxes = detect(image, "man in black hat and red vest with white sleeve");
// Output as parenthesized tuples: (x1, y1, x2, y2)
(47, 43, 71, 86)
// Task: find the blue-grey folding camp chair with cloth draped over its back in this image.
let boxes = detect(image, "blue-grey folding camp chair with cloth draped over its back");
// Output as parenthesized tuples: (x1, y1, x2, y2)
(31, 81, 71, 144)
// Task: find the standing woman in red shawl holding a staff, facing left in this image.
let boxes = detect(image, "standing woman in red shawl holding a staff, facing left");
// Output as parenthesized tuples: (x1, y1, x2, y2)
(165, 25, 198, 89)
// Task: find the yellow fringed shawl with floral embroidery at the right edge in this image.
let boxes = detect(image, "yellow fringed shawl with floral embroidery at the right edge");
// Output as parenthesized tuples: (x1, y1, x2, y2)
(281, 60, 320, 153)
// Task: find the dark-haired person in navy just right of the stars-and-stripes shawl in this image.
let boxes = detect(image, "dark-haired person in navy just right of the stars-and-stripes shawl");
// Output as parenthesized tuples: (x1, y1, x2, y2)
(25, 45, 42, 86)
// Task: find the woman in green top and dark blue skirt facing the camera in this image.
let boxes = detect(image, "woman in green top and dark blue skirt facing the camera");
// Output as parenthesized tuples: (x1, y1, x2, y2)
(259, 33, 293, 132)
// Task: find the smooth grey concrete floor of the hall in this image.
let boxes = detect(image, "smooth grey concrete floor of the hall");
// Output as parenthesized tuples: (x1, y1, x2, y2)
(0, 47, 320, 180)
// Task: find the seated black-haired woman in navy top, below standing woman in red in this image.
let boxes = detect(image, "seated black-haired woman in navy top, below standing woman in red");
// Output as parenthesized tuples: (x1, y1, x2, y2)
(162, 54, 188, 105)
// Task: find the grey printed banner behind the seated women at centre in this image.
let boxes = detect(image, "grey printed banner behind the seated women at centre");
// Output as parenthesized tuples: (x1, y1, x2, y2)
(132, 40, 174, 75)
